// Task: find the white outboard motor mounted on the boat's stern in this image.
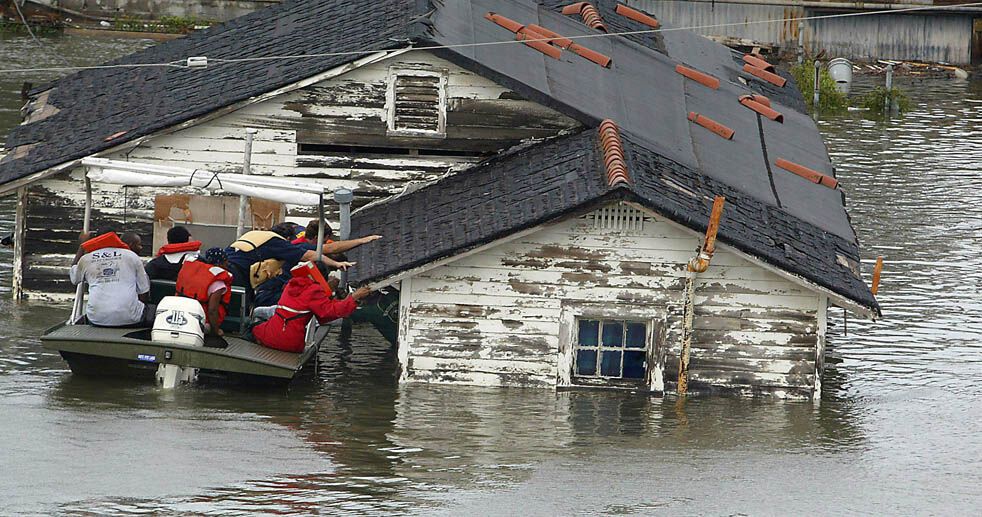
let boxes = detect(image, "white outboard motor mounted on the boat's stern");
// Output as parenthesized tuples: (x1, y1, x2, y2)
(150, 296, 205, 388)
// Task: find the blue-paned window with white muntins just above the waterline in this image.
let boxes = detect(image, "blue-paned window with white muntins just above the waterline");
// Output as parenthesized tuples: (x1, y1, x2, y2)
(573, 318, 648, 380)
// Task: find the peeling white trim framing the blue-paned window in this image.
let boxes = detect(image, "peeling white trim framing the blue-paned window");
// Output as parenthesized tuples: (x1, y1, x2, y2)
(556, 302, 667, 392)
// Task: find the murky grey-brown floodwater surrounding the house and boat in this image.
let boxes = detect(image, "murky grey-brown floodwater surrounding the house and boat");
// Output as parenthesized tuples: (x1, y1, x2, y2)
(0, 37, 982, 515)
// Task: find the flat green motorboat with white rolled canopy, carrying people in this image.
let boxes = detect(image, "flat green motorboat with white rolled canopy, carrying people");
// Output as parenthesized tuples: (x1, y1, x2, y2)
(41, 158, 350, 388)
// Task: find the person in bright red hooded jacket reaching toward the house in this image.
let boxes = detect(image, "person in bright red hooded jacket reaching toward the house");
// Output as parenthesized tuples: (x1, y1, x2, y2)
(252, 262, 372, 353)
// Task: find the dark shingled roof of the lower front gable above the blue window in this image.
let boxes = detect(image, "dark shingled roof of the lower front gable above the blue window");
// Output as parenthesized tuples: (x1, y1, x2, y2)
(348, 130, 878, 311)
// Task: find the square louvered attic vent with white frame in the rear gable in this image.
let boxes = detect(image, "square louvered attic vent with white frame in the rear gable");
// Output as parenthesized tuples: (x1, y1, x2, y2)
(385, 69, 447, 138)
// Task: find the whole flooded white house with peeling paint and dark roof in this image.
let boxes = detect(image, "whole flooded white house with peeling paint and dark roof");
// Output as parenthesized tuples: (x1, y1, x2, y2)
(0, 0, 879, 397)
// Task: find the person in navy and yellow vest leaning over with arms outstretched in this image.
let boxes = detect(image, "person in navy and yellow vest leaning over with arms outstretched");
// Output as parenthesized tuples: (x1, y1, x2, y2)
(225, 230, 354, 290)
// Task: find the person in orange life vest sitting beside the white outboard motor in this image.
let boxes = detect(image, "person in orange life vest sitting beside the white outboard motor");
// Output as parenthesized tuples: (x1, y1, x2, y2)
(176, 248, 232, 336)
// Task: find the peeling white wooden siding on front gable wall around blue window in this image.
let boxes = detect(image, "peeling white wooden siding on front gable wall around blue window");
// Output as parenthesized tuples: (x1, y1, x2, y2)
(400, 202, 824, 396)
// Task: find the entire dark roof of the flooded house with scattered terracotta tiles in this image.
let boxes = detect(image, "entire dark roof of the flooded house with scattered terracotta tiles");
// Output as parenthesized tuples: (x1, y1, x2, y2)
(0, 0, 877, 311)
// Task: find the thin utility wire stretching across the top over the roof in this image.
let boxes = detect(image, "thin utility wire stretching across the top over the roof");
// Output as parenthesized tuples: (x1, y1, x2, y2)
(0, 1, 982, 73)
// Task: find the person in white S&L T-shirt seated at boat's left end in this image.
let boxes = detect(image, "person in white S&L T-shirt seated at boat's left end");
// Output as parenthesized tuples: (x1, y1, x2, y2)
(69, 231, 156, 327)
